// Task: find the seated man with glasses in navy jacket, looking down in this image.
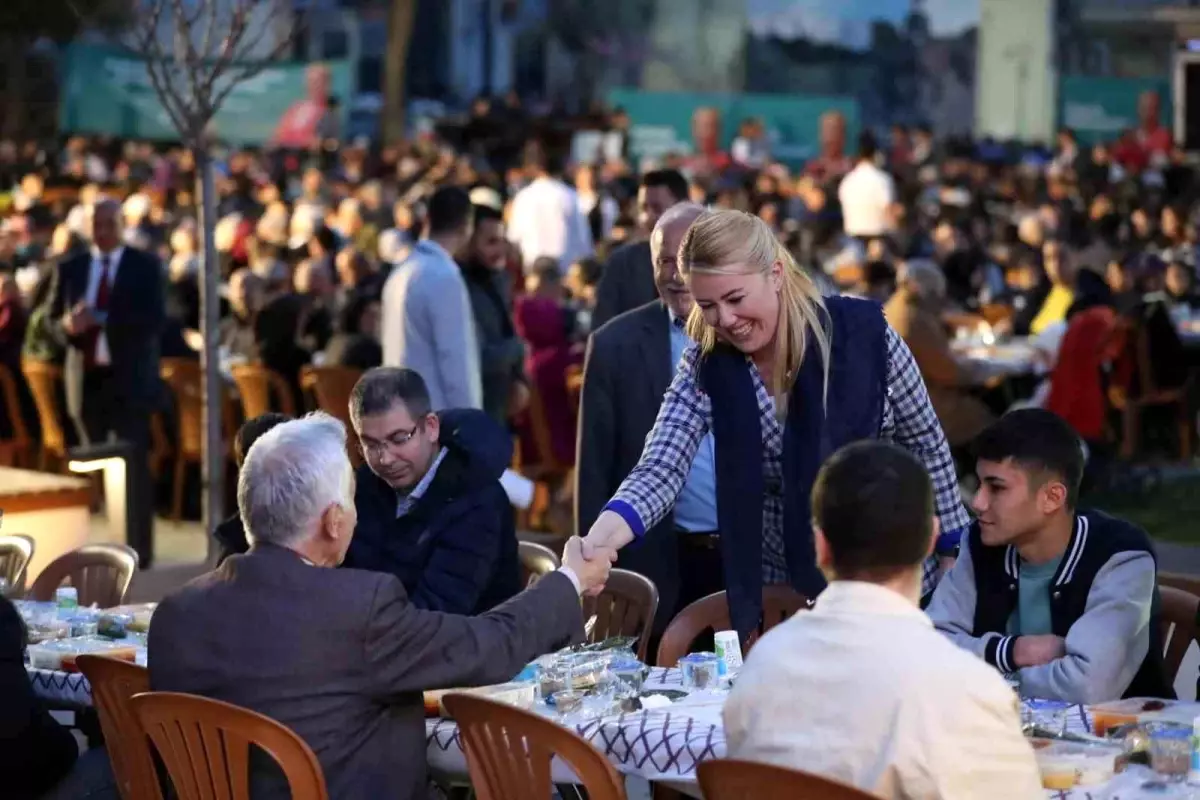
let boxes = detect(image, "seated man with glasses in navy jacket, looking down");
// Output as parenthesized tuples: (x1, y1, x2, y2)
(344, 367, 521, 614)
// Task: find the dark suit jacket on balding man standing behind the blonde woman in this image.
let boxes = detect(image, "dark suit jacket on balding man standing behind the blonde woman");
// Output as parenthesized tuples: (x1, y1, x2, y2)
(575, 300, 679, 632)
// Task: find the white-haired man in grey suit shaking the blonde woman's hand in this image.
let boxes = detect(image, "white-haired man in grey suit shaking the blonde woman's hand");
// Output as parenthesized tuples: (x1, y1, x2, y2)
(149, 413, 610, 800)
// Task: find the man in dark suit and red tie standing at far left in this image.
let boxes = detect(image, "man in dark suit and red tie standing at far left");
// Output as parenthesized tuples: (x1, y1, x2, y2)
(40, 200, 166, 567)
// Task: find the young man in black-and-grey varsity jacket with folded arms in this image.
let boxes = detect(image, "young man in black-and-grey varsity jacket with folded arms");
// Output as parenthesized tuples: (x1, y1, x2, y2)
(928, 409, 1175, 703)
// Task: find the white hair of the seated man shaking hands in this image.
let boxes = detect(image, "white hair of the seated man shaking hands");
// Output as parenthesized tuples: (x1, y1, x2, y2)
(238, 411, 354, 547)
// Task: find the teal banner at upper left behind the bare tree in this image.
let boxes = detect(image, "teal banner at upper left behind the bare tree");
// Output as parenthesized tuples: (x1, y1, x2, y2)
(59, 43, 354, 148)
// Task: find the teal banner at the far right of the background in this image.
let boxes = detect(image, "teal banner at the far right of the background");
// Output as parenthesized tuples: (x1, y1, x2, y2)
(1058, 76, 1171, 145)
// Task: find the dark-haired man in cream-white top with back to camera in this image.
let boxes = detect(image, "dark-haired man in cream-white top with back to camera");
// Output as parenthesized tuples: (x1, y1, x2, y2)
(725, 441, 1044, 800)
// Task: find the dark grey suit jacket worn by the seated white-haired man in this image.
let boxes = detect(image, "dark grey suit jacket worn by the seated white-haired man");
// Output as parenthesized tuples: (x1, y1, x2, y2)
(149, 545, 583, 800)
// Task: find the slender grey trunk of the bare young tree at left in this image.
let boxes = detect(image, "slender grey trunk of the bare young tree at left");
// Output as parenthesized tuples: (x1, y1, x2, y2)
(192, 144, 224, 565)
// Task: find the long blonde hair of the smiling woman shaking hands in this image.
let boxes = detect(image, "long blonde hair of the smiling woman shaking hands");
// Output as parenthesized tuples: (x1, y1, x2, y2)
(679, 211, 830, 405)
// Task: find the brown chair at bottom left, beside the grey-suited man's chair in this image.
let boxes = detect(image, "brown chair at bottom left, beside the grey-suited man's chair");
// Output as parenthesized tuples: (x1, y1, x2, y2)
(76, 655, 162, 800)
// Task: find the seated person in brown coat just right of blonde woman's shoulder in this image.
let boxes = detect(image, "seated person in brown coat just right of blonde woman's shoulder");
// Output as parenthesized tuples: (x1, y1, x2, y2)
(883, 259, 995, 447)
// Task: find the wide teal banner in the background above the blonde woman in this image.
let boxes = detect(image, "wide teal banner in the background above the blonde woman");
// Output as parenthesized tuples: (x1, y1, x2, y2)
(608, 89, 859, 166)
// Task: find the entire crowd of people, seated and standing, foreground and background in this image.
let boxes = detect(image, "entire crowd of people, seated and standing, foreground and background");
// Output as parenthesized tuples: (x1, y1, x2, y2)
(0, 84, 1200, 798)
